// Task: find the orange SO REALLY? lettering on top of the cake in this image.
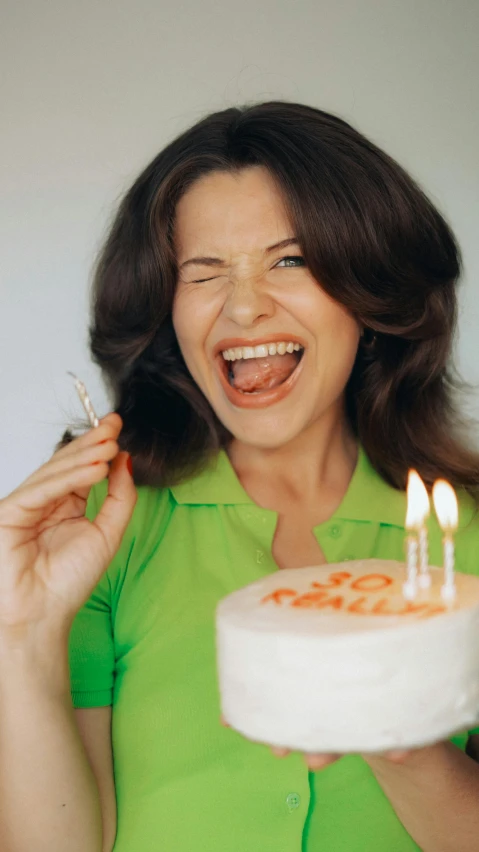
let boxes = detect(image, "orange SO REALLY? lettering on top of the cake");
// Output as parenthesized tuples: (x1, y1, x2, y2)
(260, 571, 445, 617)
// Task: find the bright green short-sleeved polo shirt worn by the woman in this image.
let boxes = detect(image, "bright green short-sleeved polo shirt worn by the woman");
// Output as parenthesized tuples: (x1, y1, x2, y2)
(70, 450, 479, 852)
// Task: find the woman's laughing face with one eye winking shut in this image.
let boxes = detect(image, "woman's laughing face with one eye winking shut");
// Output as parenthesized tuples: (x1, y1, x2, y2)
(173, 166, 360, 449)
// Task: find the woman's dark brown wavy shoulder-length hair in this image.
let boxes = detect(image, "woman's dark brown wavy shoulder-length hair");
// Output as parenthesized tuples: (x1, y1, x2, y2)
(63, 101, 479, 497)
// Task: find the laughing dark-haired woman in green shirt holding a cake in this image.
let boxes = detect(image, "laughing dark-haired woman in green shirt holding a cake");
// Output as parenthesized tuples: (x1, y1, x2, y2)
(0, 102, 479, 852)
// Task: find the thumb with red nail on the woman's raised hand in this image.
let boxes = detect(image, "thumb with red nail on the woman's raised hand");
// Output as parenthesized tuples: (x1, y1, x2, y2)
(93, 452, 137, 558)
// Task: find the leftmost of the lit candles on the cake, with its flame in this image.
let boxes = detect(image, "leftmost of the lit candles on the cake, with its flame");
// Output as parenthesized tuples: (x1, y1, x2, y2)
(403, 470, 431, 600)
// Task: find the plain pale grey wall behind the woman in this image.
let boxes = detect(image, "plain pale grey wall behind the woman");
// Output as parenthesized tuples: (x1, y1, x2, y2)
(0, 0, 479, 496)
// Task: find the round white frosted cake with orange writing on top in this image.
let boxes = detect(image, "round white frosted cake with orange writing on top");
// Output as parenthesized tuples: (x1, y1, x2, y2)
(216, 559, 479, 753)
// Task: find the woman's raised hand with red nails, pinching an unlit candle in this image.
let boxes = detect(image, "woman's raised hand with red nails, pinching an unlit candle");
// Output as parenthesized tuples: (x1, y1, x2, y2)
(0, 413, 136, 639)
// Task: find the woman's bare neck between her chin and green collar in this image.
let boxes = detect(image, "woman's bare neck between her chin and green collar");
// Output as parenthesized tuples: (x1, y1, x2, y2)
(228, 402, 358, 503)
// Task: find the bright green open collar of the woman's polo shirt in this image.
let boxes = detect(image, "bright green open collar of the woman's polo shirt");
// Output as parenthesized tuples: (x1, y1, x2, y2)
(170, 445, 475, 528)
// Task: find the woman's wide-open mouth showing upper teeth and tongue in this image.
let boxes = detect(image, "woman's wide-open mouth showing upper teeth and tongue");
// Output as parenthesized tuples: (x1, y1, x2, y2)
(218, 339, 304, 405)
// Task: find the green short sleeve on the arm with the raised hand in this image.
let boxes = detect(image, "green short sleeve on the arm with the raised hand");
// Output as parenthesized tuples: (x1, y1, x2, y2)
(68, 481, 115, 708)
